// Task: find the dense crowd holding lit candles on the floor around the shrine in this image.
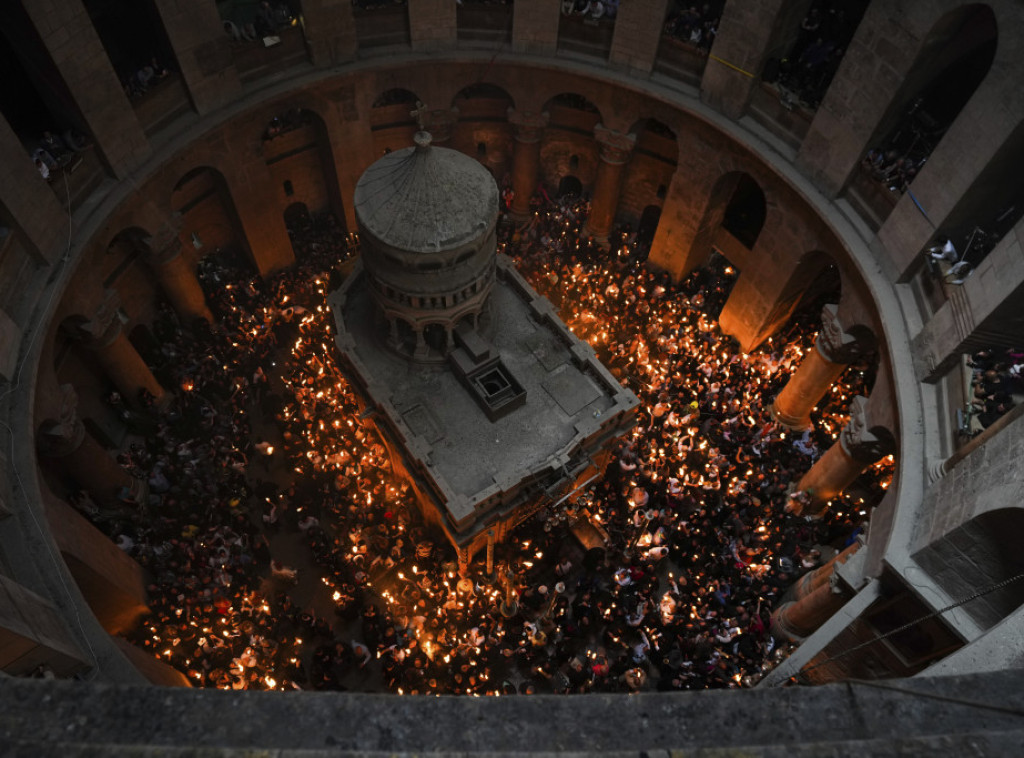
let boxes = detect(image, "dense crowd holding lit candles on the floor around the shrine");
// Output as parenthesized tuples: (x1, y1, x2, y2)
(77, 188, 891, 694)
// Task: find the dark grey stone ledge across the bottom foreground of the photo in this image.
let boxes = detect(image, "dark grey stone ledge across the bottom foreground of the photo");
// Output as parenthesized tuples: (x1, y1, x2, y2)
(0, 670, 1024, 757)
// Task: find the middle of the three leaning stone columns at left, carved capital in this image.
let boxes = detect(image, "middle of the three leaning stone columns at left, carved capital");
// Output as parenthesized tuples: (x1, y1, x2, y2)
(78, 290, 167, 405)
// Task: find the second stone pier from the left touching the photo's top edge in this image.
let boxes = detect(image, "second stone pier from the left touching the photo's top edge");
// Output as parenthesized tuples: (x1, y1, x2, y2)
(154, 0, 242, 114)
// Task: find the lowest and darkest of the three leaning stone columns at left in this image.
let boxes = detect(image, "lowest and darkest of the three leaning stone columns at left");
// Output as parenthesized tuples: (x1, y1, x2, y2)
(36, 384, 145, 505)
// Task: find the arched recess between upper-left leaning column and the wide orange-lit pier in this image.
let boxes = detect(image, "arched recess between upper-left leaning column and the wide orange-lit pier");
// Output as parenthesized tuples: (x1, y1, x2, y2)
(171, 166, 255, 264)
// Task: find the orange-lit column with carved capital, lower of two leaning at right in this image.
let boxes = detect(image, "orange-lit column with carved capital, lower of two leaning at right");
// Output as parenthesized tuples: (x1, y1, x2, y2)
(794, 395, 894, 515)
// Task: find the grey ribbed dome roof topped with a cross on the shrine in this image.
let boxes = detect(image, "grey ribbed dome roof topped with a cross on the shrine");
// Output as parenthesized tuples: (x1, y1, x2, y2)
(355, 131, 498, 253)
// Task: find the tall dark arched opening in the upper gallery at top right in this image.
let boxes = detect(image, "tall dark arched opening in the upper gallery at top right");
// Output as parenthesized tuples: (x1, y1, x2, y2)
(844, 3, 998, 219)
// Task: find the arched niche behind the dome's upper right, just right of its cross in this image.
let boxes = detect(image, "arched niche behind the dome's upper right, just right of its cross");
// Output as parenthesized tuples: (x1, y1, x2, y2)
(451, 82, 515, 177)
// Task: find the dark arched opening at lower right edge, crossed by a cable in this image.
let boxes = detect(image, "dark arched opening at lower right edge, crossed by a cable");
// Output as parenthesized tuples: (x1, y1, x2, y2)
(913, 508, 1024, 629)
